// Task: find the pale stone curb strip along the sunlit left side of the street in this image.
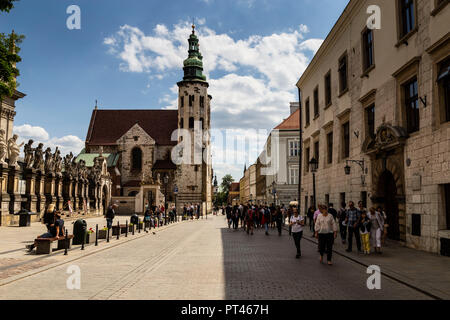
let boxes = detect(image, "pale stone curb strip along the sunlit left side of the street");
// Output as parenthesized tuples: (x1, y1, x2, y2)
(0, 221, 188, 287)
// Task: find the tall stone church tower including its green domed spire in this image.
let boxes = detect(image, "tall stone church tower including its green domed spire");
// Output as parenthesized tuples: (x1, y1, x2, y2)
(176, 25, 212, 214)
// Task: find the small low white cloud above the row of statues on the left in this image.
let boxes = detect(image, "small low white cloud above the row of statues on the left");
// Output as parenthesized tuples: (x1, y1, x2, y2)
(13, 124, 84, 155)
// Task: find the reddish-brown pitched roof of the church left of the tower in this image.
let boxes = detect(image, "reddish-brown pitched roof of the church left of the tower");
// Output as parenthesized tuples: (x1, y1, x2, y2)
(86, 110, 178, 146)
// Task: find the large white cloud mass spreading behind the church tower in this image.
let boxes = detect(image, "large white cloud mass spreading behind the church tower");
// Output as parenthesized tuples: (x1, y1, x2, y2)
(104, 21, 322, 179)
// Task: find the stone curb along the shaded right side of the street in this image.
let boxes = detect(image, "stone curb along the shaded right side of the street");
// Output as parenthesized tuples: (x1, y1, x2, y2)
(283, 226, 449, 300)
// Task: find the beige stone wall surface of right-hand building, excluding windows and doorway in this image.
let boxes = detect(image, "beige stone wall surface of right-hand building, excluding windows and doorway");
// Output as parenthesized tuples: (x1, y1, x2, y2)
(298, 0, 450, 252)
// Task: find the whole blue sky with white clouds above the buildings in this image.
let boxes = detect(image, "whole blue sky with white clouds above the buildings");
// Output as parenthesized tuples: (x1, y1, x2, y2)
(0, 0, 348, 181)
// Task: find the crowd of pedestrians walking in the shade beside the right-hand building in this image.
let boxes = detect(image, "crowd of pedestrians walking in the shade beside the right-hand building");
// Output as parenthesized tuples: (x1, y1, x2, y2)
(223, 201, 389, 266)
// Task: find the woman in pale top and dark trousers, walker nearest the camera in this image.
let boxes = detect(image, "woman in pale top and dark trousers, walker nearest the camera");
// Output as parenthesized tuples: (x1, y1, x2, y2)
(314, 205, 337, 266)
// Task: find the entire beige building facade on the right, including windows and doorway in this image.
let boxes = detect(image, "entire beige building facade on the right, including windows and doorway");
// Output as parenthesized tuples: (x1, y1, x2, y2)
(297, 0, 450, 254)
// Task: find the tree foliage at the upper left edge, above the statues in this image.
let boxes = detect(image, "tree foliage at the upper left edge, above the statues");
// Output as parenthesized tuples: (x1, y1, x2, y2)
(0, 0, 25, 100)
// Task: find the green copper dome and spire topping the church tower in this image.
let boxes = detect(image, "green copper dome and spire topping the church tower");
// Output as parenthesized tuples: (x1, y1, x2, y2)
(183, 25, 206, 81)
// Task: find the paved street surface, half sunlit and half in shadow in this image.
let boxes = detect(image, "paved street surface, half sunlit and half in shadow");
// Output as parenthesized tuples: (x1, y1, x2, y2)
(0, 216, 440, 300)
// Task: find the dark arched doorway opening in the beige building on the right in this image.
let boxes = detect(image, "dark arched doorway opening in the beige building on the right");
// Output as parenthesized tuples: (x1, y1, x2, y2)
(377, 170, 400, 240)
